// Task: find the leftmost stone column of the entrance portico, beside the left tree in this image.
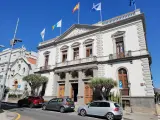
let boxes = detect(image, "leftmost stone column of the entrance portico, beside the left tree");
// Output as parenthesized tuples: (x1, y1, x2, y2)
(52, 73, 59, 98)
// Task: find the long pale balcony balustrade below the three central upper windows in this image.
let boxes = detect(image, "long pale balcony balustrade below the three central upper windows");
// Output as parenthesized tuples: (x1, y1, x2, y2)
(56, 56, 97, 67)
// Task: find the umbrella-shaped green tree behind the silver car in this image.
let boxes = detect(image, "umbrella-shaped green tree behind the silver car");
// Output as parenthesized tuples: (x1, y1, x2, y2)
(90, 77, 117, 100)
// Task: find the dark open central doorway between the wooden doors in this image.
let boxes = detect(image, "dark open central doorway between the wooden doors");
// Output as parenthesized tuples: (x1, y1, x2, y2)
(71, 83, 78, 102)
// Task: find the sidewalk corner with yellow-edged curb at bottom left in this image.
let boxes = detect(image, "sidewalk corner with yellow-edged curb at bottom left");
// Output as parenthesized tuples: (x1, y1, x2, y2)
(0, 111, 17, 120)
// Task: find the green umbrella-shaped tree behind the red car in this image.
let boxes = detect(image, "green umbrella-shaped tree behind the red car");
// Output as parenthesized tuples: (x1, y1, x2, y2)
(23, 74, 48, 95)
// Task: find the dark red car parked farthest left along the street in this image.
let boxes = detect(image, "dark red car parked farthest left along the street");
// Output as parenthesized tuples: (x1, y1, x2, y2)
(17, 96, 44, 108)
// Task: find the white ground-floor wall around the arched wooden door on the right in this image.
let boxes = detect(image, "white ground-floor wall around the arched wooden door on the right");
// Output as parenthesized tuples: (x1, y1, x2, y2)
(104, 60, 146, 96)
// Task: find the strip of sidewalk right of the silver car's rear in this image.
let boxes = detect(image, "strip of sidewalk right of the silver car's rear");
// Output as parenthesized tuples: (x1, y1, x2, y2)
(123, 112, 158, 120)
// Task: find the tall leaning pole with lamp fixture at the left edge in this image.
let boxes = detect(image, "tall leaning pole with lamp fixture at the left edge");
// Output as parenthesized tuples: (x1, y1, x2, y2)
(0, 18, 22, 109)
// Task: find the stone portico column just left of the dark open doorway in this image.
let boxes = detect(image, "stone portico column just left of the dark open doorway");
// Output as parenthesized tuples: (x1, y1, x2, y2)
(64, 72, 71, 97)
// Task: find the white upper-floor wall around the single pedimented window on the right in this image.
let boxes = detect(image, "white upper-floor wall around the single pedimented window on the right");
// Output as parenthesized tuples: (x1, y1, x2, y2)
(103, 21, 141, 56)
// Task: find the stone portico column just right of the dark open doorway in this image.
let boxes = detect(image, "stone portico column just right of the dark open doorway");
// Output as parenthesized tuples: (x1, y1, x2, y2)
(77, 70, 84, 105)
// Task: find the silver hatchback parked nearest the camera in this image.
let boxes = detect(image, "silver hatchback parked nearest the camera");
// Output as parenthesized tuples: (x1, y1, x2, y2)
(77, 100, 123, 120)
